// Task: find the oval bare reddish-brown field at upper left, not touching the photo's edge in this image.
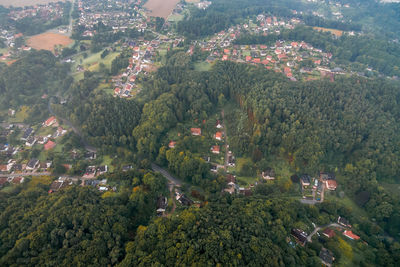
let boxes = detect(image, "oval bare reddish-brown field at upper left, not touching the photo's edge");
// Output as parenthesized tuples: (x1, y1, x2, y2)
(27, 33, 73, 52)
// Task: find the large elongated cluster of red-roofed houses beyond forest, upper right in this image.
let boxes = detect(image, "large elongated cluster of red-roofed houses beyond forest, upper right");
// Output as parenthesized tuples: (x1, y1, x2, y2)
(189, 14, 344, 81)
